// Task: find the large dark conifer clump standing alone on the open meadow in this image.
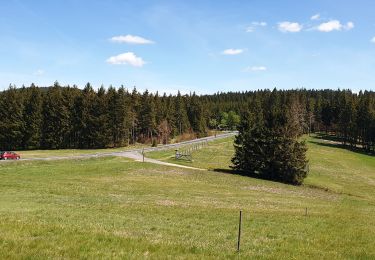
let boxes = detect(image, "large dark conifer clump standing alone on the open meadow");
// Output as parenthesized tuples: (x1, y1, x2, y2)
(232, 97, 307, 185)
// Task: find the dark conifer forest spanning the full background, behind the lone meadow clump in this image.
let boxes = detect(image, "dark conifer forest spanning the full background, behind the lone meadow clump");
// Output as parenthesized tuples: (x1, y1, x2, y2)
(0, 82, 375, 152)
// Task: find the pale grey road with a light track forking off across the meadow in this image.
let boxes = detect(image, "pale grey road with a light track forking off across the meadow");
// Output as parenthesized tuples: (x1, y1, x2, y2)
(0, 132, 237, 170)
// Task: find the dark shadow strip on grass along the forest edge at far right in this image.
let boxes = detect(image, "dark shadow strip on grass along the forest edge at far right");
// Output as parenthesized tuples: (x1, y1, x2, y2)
(308, 133, 375, 156)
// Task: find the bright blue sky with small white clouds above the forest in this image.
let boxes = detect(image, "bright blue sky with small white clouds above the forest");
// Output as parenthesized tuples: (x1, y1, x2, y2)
(0, 0, 375, 94)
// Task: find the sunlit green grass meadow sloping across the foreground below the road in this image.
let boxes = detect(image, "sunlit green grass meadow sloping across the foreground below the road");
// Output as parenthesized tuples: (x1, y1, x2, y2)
(0, 136, 375, 259)
